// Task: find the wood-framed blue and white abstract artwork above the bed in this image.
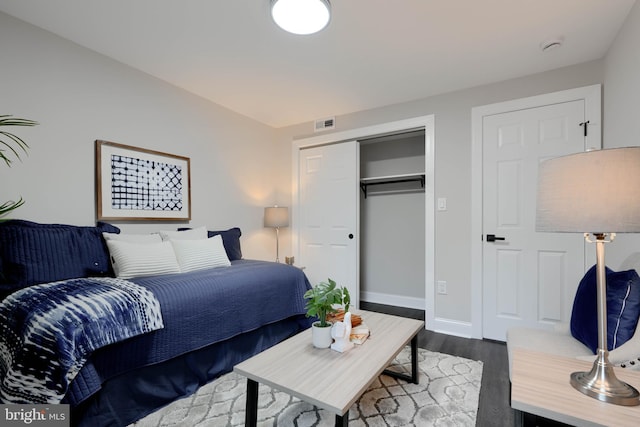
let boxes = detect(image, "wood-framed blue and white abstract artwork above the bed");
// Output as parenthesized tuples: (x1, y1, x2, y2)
(96, 140, 191, 221)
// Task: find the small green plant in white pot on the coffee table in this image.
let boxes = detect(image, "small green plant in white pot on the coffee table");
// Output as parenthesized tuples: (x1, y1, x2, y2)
(304, 279, 351, 348)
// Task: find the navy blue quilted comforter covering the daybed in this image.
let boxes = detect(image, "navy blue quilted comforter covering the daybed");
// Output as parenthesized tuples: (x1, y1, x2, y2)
(65, 260, 310, 405)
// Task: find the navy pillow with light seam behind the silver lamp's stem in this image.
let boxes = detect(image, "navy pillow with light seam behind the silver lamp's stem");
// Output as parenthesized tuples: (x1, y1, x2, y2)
(571, 265, 640, 354)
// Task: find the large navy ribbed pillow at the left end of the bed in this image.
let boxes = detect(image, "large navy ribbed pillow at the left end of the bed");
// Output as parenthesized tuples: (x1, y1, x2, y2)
(0, 219, 120, 291)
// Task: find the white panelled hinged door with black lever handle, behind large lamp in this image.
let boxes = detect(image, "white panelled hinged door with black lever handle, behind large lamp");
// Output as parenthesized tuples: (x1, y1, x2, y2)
(482, 100, 586, 341)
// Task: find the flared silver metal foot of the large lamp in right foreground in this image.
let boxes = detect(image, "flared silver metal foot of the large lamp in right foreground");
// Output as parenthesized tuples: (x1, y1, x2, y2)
(571, 350, 640, 406)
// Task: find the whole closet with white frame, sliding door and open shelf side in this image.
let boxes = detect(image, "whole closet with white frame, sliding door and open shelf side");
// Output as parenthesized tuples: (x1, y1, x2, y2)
(291, 115, 435, 318)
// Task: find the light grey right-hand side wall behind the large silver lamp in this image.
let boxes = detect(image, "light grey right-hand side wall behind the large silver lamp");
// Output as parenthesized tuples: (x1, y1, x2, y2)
(603, 2, 640, 268)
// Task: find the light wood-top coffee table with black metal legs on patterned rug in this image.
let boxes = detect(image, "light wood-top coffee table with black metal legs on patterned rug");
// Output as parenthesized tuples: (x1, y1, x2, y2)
(233, 311, 424, 427)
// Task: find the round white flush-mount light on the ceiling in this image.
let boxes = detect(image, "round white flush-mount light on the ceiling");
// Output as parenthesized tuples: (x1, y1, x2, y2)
(271, 0, 331, 35)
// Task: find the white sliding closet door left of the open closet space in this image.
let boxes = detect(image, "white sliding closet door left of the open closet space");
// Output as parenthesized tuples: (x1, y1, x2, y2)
(298, 141, 360, 308)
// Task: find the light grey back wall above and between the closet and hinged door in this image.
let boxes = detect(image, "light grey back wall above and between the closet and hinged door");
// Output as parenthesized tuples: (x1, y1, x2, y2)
(279, 60, 603, 323)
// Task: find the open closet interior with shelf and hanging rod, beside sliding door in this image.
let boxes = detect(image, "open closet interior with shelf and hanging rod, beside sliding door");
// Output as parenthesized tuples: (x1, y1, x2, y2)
(358, 130, 425, 309)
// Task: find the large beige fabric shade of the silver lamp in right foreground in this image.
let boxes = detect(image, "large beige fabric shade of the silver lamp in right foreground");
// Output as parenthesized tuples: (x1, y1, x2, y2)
(536, 147, 640, 233)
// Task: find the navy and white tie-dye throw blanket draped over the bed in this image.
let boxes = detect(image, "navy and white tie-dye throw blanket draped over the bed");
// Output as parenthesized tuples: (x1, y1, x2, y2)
(0, 278, 164, 404)
